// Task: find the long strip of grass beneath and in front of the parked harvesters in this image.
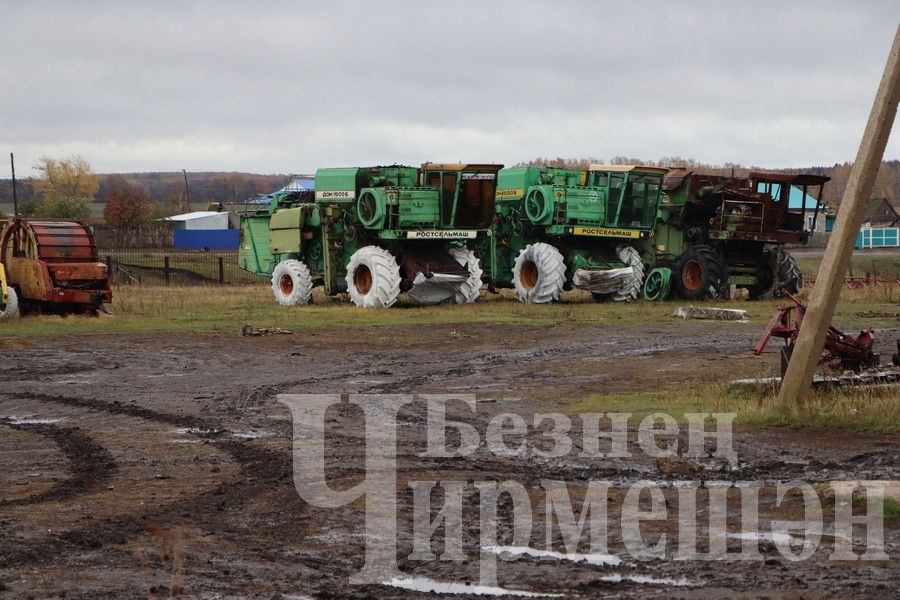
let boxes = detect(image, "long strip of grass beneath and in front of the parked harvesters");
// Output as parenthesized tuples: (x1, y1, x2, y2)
(0, 279, 900, 336)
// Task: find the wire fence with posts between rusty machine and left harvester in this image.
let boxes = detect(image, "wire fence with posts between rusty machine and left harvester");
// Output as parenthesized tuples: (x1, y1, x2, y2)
(99, 248, 265, 285)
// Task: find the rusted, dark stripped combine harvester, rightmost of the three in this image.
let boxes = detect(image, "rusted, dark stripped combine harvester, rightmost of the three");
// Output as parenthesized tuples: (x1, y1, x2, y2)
(642, 169, 829, 300)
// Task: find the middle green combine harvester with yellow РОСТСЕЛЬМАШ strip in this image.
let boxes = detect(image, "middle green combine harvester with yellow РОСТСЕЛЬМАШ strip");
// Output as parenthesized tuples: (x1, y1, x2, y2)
(479, 165, 667, 304)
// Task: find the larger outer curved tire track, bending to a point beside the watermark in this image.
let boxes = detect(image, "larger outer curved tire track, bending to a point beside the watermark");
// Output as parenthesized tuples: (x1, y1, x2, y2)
(0, 392, 293, 568)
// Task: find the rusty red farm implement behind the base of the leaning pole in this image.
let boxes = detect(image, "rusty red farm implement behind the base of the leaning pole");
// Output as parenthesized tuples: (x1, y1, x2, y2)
(753, 290, 880, 377)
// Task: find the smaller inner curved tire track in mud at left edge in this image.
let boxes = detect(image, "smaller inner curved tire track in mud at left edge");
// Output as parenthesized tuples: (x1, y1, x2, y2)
(0, 421, 118, 508)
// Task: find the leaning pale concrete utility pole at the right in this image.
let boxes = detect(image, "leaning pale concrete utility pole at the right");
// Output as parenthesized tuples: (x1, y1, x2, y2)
(778, 27, 900, 406)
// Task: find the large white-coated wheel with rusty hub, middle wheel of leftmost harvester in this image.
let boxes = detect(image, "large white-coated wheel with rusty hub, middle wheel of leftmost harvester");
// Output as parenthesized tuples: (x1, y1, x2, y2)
(347, 246, 400, 308)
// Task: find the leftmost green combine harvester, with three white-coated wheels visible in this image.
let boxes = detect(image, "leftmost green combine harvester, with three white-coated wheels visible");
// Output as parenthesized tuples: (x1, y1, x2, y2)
(238, 163, 502, 307)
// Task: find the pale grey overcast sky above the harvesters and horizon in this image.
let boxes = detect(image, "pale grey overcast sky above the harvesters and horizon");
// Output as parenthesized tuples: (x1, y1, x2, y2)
(0, 0, 900, 177)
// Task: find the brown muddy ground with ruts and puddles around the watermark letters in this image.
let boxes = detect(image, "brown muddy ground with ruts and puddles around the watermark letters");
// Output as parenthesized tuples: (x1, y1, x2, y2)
(0, 323, 900, 599)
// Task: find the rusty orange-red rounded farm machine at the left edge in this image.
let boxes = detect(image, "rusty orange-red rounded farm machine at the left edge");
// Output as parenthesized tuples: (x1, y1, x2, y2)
(0, 218, 112, 314)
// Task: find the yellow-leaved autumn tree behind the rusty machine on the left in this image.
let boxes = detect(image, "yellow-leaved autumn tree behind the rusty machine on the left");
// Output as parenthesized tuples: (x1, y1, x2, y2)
(31, 156, 100, 219)
